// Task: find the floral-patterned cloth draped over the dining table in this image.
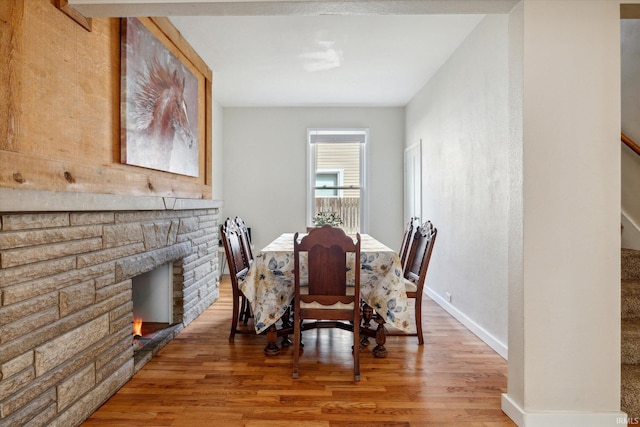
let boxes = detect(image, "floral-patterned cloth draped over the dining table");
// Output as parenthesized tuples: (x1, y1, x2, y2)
(239, 233, 410, 333)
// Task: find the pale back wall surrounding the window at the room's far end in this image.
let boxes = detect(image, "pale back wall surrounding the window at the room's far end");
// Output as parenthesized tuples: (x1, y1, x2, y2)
(222, 108, 405, 250)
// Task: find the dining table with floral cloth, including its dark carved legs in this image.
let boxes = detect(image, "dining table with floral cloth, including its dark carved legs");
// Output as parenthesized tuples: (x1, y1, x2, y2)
(238, 233, 411, 357)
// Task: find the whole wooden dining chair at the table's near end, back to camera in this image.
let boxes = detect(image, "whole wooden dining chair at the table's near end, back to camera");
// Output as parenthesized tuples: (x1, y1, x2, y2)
(293, 225, 360, 381)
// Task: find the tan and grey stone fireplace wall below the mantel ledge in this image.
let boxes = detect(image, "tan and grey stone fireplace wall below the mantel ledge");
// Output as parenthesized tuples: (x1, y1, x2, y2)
(0, 199, 219, 427)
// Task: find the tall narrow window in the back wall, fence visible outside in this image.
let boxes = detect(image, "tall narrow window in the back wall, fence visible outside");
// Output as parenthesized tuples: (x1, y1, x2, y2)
(307, 129, 368, 233)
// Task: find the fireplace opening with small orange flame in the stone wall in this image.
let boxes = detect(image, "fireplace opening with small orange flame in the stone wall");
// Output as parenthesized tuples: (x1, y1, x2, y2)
(131, 263, 182, 372)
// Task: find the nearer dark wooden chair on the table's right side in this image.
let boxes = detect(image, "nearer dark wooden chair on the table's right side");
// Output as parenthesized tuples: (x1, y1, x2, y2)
(387, 221, 438, 345)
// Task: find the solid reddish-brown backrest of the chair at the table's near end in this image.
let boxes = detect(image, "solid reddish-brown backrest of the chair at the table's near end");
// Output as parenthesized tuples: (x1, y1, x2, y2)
(293, 225, 360, 304)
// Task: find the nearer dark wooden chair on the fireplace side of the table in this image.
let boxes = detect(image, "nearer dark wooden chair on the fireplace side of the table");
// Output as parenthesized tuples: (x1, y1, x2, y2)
(220, 218, 255, 342)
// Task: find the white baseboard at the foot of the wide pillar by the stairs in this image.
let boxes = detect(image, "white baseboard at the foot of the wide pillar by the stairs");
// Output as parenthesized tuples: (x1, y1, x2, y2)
(502, 394, 628, 427)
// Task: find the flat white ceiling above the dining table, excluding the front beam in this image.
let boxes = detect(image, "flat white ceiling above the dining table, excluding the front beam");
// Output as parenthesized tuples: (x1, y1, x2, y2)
(170, 14, 484, 107)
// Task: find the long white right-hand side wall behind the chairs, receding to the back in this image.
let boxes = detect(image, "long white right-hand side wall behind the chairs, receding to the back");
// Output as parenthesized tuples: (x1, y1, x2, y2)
(406, 15, 509, 357)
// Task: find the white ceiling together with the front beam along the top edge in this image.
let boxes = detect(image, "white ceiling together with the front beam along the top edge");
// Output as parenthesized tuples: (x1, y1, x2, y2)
(66, 0, 518, 107)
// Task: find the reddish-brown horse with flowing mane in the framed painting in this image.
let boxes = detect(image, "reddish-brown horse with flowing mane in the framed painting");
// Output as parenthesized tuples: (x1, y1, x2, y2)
(132, 58, 196, 171)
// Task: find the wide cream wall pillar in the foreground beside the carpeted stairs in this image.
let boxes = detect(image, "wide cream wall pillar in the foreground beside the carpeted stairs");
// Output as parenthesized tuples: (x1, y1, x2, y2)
(502, 0, 620, 427)
